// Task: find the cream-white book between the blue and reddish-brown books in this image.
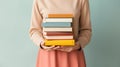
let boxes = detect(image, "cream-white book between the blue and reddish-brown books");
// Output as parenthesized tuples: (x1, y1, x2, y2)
(43, 27, 72, 32)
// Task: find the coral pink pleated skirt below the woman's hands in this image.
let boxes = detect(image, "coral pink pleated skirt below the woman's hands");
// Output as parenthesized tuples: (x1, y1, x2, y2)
(36, 49, 86, 67)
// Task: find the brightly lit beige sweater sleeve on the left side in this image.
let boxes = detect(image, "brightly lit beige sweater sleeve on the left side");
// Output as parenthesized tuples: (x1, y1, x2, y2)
(29, 0, 44, 46)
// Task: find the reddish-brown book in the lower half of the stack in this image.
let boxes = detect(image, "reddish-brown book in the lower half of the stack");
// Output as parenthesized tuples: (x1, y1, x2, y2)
(43, 32, 73, 36)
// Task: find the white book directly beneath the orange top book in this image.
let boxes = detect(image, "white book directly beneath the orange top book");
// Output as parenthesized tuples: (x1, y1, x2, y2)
(43, 18, 72, 22)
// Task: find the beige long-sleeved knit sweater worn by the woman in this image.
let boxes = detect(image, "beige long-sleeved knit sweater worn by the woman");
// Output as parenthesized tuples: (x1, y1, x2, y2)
(29, 0, 91, 48)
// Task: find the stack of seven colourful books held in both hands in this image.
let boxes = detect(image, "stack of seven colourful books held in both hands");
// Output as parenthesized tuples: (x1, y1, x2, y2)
(42, 14, 74, 46)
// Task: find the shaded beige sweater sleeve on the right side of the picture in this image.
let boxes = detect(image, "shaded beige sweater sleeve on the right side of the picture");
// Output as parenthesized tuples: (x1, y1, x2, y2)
(77, 0, 92, 48)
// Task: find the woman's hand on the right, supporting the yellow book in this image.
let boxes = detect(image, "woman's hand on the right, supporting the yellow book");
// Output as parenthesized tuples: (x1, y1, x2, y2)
(57, 43, 80, 52)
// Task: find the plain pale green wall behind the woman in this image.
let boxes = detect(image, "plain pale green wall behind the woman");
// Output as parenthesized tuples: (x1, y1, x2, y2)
(0, 0, 120, 67)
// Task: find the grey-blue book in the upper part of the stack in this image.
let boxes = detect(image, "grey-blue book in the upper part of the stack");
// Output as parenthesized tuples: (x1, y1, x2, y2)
(42, 22, 72, 27)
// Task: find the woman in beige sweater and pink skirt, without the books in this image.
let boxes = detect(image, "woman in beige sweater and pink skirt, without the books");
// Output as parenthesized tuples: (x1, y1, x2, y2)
(29, 0, 91, 67)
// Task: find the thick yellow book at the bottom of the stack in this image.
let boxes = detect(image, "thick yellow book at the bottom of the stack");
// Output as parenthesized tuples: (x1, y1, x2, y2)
(45, 39, 75, 46)
